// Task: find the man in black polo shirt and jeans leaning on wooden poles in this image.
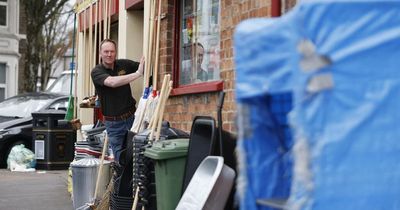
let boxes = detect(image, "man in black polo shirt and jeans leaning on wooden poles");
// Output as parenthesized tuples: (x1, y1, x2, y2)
(91, 39, 144, 163)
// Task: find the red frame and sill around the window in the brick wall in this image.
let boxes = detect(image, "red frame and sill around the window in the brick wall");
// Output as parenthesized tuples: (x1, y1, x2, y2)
(171, 0, 224, 96)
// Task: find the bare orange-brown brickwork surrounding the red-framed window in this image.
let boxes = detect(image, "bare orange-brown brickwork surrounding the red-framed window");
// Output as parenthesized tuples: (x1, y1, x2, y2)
(159, 0, 295, 133)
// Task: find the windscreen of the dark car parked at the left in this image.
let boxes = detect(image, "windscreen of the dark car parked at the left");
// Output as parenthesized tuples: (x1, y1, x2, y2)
(0, 96, 52, 117)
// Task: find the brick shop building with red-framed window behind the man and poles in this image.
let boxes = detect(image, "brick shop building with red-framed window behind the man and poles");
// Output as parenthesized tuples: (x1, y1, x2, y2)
(78, 0, 295, 133)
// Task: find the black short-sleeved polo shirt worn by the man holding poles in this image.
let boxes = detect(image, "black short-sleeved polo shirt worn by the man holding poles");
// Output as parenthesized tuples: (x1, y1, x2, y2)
(91, 59, 139, 116)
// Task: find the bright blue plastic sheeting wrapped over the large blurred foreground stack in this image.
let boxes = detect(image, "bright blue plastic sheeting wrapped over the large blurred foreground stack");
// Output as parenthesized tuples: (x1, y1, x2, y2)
(235, 0, 400, 210)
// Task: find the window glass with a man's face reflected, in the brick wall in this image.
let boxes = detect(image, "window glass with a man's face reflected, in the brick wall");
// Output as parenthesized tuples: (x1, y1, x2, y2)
(179, 0, 220, 86)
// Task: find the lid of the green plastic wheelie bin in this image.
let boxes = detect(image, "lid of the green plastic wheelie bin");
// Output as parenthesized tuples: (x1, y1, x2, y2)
(144, 139, 189, 160)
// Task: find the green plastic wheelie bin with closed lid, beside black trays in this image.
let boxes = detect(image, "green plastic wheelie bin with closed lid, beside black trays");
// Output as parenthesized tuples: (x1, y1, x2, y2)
(144, 139, 189, 210)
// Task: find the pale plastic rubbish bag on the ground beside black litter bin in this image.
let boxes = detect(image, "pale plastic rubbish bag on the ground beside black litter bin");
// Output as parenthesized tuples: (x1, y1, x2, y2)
(7, 144, 36, 171)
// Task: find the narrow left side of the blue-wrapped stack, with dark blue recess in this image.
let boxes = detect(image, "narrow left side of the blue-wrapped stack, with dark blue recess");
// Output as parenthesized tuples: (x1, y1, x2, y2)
(235, 10, 297, 210)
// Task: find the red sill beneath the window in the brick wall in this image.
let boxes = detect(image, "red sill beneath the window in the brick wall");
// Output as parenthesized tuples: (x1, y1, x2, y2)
(171, 81, 224, 96)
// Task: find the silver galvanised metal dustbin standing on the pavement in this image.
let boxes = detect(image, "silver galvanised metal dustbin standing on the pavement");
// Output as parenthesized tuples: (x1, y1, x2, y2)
(71, 158, 110, 209)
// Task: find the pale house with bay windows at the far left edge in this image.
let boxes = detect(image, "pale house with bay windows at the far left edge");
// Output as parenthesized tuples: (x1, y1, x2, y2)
(0, 0, 26, 101)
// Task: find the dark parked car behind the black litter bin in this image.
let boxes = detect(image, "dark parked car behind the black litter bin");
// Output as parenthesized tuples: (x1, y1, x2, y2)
(0, 92, 69, 167)
